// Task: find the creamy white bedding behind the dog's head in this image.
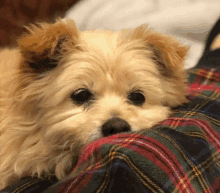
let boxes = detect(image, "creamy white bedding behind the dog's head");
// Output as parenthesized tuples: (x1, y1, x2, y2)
(66, 0, 220, 68)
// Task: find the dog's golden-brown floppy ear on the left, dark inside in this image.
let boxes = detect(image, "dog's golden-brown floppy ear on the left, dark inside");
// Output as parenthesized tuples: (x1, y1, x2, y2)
(18, 19, 78, 73)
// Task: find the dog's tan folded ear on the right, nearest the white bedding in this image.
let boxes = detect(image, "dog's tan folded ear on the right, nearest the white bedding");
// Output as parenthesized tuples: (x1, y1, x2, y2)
(132, 25, 189, 76)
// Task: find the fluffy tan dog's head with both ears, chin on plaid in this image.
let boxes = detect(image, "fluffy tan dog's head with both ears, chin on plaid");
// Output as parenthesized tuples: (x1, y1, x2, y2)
(12, 20, 188, 177)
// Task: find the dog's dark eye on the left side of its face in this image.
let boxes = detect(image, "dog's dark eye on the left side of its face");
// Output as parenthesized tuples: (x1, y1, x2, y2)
(71, 89, 93, 105)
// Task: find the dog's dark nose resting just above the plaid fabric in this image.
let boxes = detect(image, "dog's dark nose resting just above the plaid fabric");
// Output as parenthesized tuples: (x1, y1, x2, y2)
(102, 117, 131, 137)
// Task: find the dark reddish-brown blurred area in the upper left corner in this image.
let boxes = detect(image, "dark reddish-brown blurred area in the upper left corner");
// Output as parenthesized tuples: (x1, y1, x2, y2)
(0, 0, 78, 47)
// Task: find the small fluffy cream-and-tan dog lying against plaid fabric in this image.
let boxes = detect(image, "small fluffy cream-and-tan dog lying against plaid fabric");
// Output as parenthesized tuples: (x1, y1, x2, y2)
(0, 19, 188, 188)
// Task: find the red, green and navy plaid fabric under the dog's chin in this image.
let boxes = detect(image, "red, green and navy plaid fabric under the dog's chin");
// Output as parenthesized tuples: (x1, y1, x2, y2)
(3, 68, 220, 193)
